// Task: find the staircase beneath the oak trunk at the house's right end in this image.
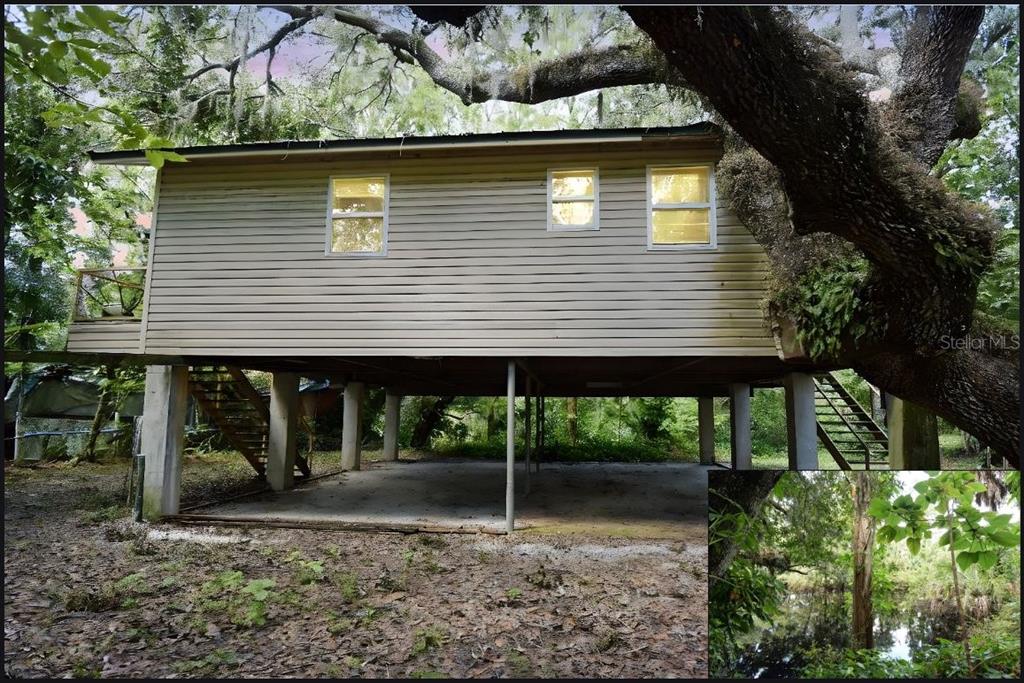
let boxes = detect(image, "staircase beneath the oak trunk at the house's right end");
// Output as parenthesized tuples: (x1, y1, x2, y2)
(814, 373, 889, 470)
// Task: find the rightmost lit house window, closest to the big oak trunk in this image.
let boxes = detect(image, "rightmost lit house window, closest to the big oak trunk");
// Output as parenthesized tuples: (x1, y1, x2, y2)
(647, 166, 717, 249)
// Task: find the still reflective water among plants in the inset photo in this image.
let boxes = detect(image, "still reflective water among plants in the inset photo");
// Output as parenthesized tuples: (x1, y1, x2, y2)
(732, 592, 955, 678)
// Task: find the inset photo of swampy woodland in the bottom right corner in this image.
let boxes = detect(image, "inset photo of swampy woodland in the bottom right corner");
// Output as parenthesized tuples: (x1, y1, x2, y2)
(708, 471, 1021, 679)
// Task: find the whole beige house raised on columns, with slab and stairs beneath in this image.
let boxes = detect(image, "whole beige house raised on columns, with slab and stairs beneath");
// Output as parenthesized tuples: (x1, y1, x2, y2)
(14, 124, 938, 532)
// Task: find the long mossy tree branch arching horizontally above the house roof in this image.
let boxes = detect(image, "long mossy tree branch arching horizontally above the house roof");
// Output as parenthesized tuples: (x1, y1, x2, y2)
(264, 5, 678, 104)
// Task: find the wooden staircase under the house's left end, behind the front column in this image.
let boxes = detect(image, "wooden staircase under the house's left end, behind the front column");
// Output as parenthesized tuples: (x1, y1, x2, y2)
(188, 366, 309, 478)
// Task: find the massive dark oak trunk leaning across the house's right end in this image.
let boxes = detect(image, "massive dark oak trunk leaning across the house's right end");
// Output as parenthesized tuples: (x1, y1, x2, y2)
(625, 6, 1020, 466)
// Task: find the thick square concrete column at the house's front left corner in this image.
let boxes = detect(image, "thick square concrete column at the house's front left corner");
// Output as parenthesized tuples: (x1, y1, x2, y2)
(141, 366, 188, 520)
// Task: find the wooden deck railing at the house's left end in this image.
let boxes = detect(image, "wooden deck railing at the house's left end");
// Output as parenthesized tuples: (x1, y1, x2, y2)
(72, 268, 145, 323)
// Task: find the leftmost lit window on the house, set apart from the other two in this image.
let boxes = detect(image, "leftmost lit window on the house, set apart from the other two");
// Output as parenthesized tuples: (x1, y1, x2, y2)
(327, 176, 388, 256)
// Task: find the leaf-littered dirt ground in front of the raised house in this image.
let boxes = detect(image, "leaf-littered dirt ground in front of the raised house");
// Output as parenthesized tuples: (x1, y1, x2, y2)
(4, 459, 707, 678)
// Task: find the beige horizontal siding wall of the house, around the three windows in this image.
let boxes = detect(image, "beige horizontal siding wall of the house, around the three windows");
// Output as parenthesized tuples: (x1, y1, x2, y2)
(145, 142, 775, 355)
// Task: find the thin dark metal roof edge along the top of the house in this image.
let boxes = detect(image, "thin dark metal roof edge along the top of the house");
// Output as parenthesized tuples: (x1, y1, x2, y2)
(88, 122, 719, 166)
